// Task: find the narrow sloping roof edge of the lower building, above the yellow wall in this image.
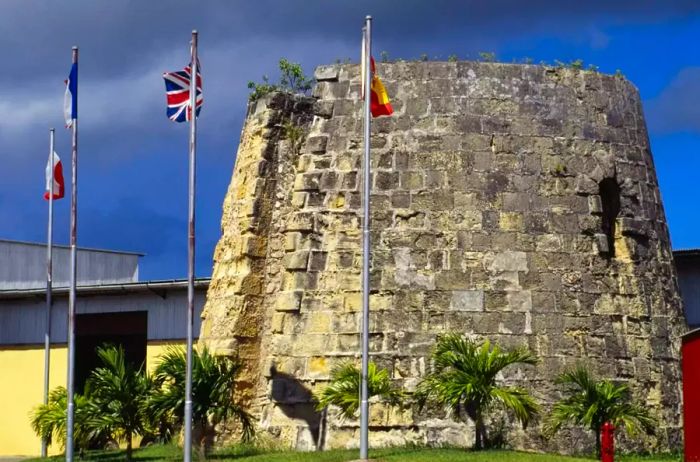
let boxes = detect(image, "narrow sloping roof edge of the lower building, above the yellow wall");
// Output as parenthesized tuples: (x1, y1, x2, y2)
(0, 278, 211, 300)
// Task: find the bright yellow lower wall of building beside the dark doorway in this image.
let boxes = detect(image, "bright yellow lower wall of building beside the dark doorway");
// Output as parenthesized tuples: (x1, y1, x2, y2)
(0, 342, 184, 457)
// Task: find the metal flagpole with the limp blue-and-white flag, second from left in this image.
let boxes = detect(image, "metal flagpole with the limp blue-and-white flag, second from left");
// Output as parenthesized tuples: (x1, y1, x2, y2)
(65, 47, 78, 462)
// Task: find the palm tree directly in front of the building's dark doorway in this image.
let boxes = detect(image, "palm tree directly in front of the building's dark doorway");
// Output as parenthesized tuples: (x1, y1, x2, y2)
(85, 346, 151, 460)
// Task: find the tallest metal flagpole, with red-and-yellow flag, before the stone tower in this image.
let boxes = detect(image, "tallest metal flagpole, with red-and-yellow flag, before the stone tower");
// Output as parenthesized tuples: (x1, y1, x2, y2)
(360, 16, 372, 460)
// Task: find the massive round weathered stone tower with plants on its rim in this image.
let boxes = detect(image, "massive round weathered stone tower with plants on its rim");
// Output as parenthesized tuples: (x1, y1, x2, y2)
(201, 62, 685, 451)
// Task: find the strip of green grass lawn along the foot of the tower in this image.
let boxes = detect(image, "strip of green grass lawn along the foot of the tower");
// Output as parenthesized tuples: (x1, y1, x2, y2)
(31, 445, 682, 462)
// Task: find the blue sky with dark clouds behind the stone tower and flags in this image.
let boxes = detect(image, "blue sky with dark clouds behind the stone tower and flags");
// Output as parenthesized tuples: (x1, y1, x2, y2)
(0, 0, 700, 280)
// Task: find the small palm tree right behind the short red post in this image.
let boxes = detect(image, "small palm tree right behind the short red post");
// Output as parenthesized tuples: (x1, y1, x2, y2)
(544, 365, 655, 456)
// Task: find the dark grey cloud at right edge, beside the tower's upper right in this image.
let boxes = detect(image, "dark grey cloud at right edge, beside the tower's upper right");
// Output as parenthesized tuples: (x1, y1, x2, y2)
(648, 67, 700, 134)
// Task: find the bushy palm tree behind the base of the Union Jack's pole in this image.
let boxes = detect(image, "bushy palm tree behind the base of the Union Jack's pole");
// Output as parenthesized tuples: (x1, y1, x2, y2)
(149, 347, 253, 456)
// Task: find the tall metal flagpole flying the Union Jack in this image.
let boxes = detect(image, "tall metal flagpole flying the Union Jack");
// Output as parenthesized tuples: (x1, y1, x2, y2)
(185, 30, 199, 462)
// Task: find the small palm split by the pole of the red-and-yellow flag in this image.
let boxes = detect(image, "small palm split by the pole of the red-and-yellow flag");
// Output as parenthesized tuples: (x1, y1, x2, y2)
(316, 361, 406, 419)
